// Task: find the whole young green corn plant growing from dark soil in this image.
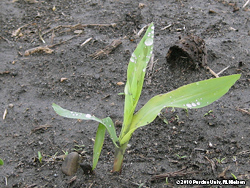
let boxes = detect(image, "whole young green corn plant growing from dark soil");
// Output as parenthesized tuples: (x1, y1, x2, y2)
(52, 23, 240, 172)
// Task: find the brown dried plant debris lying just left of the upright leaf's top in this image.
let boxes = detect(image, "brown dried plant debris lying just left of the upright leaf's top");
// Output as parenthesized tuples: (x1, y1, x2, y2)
(90, 39, 122, 59)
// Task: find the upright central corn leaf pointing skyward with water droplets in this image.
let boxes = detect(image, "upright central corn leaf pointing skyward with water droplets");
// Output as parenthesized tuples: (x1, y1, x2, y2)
(120, 23, 154, 140)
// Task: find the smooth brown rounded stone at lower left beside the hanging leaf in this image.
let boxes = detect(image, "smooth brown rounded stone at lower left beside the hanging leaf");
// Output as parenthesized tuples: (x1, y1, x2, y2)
(62, 152, 79, 176)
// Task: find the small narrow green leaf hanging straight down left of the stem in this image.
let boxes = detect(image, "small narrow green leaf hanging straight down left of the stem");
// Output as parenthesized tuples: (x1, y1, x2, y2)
(92, 123, 106, 170)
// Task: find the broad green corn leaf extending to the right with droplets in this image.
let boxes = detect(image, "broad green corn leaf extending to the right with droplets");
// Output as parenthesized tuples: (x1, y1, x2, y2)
(120, 74, 241, 144)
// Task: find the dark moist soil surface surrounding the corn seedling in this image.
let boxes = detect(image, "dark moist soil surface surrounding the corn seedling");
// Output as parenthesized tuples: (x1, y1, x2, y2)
(0, 0, 250, 188)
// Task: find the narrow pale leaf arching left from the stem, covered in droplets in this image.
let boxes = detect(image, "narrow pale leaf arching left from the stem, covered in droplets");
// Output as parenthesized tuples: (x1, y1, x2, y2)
(52, 103, 118, 147)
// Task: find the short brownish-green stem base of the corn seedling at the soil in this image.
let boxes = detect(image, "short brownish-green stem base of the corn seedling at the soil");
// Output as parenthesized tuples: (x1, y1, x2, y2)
(112, 142, 128, 172)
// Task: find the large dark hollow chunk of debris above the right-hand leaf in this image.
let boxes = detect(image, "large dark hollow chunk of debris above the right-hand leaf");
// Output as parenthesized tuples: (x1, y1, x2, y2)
(166, 35, 207, 69)
